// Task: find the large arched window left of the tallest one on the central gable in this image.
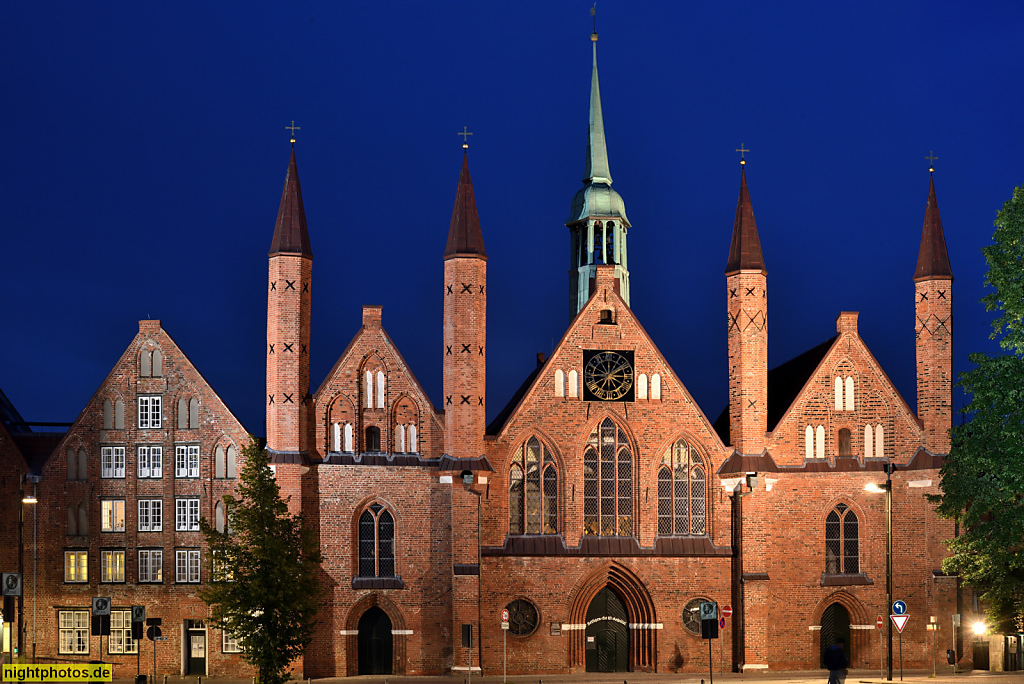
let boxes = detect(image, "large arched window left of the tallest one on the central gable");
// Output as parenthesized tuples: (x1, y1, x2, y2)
(509, 437, 558, 535)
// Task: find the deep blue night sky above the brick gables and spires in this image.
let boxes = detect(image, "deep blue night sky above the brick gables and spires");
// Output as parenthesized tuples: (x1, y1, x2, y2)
(0, 0, 1024, 434)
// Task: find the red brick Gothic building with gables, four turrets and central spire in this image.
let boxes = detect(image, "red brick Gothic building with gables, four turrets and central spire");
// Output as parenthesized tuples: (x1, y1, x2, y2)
(0, 29, 959, 677)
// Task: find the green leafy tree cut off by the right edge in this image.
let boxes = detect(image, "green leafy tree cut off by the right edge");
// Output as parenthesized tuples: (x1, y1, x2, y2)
(936, 187, 1024, 629)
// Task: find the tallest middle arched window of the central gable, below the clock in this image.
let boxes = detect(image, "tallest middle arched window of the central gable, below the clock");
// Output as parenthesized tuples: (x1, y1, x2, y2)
(583, 418, 633, 537)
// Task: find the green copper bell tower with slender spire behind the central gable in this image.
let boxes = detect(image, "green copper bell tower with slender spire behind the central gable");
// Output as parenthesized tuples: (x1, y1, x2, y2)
(565, 32, 630, 318)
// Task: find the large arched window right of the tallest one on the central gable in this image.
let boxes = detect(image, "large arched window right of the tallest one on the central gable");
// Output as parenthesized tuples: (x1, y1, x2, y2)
(657, 439, 708, 535)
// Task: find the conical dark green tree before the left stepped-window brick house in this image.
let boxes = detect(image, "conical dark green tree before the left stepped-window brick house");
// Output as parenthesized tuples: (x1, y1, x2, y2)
(199, 438, 322, 684)
